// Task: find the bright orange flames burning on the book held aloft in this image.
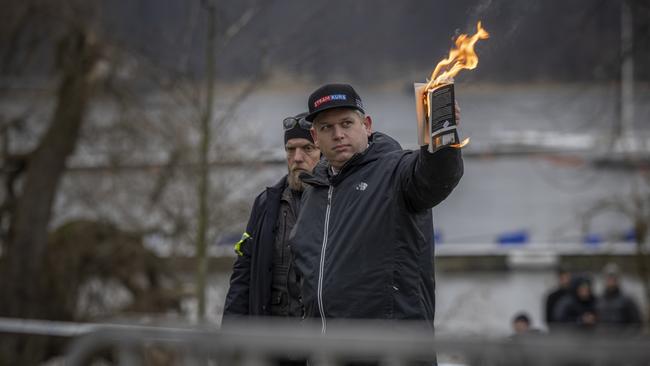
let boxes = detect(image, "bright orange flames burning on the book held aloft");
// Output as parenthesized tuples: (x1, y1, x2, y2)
(424, 21, 490, 148)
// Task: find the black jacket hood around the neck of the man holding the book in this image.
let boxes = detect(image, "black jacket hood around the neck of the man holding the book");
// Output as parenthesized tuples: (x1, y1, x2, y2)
(300, 132, 402, 185)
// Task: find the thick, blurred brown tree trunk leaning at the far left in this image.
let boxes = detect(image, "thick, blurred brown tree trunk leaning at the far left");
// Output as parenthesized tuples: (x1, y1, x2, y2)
(0, 28, 98, 364)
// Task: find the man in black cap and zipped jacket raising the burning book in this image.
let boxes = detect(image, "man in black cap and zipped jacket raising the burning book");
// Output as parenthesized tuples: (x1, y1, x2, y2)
(290, 84, 463, 332)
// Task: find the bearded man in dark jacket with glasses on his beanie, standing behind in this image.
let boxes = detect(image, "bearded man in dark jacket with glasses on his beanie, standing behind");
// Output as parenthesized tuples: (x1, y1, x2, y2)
(224, 113, 320, 318)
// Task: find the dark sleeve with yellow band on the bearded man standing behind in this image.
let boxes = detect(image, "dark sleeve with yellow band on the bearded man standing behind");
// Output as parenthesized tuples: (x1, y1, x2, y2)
(223, 196, 261, 320)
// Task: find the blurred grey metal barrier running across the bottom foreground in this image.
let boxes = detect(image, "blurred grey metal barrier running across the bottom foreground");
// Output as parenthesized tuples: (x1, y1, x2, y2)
(0, 319, 650, 366)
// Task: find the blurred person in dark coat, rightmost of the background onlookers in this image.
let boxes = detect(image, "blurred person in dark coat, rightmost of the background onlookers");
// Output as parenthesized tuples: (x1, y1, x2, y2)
(596, 263, 642, 335)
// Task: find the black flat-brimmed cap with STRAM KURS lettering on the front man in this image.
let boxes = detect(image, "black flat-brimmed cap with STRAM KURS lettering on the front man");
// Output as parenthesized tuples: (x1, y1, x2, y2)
(305, 84, 366, 122)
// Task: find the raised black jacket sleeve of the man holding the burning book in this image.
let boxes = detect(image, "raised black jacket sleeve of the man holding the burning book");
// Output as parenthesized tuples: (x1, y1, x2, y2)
(400, 146, 463, 212)
